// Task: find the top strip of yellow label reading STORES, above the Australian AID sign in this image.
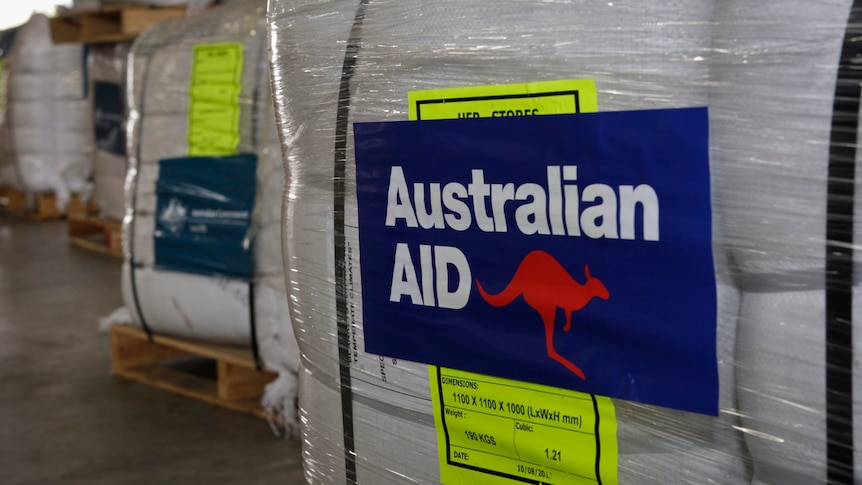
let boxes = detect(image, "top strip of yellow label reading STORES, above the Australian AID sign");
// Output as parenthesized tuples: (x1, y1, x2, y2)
(407, 79, 598, 120)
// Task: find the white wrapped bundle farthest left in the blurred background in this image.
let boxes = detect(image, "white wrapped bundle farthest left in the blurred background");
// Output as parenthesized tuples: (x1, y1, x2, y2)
(0, 14, 92, 207)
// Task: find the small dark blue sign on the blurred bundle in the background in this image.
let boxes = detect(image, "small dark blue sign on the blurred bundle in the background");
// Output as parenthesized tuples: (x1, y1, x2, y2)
(93, 81, 126, 155)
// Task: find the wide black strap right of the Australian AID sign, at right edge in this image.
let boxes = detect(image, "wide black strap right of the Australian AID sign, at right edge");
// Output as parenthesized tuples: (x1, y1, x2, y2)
(826, 0, 862, 484)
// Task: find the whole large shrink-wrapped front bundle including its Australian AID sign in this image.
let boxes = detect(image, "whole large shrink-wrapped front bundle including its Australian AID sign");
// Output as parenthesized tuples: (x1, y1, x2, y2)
(269, 0, 862, 484)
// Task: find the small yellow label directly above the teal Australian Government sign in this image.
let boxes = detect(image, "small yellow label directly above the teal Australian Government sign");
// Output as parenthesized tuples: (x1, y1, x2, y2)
(188, 42, 243, 156)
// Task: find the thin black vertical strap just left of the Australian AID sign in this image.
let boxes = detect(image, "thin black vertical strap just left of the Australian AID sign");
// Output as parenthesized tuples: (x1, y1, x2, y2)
(333, 0, 368, 484)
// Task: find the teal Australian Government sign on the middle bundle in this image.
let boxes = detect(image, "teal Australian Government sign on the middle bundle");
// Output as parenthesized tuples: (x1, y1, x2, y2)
(153, 154, 257, 279)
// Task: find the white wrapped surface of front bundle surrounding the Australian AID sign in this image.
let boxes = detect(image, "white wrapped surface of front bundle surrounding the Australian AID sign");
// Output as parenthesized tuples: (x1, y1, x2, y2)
(269, 0, 862, 484)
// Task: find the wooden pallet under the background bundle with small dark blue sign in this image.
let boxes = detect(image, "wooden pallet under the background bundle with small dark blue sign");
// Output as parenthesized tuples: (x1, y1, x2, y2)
(66, 201, 123, 259)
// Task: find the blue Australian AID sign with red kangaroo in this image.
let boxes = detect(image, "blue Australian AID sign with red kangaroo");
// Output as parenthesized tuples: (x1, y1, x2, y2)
(354, 108, 718, 415)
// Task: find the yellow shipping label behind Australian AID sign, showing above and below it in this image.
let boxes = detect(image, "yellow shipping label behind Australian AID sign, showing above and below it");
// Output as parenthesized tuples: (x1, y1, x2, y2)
(416, 79, 618, 485)
